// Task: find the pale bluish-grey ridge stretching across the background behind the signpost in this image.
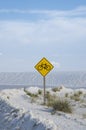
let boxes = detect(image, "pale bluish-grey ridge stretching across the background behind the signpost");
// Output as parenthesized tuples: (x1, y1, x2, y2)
(0, 71, 86, 88)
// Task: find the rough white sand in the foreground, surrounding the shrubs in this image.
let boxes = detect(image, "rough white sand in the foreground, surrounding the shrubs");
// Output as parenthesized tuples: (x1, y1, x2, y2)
(0, 87, 86, 130)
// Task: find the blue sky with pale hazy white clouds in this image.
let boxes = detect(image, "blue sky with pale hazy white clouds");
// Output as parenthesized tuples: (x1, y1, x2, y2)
(0, 0, 86, 72)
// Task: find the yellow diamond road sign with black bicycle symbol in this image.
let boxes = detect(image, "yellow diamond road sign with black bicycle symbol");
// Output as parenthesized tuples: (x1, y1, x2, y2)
(35, 58, 54, 76)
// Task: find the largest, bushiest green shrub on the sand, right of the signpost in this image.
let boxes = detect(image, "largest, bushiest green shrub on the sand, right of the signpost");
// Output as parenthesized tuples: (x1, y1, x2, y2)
(52, 99, 72, 113)
